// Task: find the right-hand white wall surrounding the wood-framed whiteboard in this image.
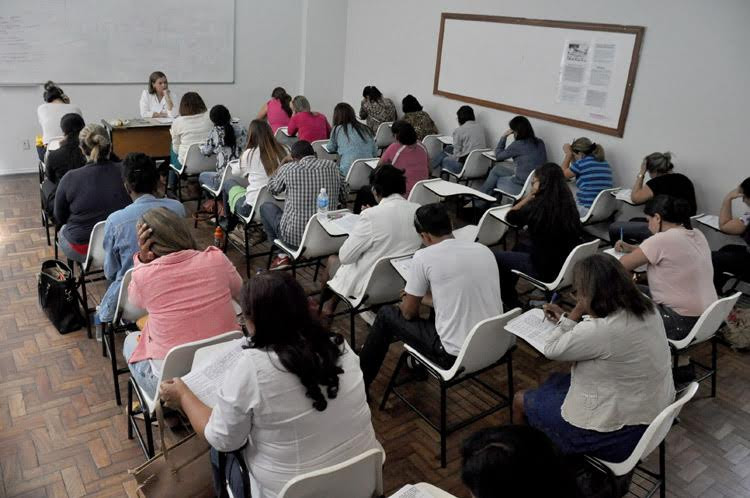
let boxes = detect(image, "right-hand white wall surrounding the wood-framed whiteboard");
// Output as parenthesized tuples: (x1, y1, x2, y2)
(344, 0, 750, 213)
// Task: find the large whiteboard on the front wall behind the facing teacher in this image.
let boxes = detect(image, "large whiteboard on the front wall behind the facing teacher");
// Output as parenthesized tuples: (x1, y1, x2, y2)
(0, 0, 234, 85)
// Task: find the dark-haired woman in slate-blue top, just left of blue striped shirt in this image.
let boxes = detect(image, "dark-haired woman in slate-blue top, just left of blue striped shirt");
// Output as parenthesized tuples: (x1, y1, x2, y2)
(480, 116, 547, 195)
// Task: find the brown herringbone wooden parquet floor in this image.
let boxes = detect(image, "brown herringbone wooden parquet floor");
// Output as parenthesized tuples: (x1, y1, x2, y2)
(0, 175, 750, 498)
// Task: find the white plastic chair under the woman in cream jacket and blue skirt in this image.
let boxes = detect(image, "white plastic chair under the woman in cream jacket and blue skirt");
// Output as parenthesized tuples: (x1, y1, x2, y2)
(586, 382, 698, 498)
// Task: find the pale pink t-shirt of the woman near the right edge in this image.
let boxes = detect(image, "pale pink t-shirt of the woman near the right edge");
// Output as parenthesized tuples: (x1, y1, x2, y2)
(640, 228, 718, 316)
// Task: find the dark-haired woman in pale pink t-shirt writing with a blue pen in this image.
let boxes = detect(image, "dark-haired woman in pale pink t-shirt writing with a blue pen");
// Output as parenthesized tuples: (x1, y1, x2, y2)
(615, 195, 718, 340)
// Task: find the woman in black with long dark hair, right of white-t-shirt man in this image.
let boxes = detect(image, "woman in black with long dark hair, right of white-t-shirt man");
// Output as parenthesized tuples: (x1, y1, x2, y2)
(495, 163, 583, 308)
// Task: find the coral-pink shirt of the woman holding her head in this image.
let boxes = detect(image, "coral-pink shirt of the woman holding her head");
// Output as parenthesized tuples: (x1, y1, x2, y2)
(128, 247, 242, 363)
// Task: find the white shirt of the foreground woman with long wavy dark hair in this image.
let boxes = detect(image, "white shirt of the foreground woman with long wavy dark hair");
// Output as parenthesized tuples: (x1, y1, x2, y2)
(205, 343, 381, 498)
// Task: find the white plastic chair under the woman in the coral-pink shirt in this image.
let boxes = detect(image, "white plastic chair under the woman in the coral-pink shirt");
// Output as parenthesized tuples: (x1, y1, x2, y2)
(127, 330, 243, 458)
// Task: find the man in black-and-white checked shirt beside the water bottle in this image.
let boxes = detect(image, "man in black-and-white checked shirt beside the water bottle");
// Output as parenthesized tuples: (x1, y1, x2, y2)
(260, 140, 346, 269)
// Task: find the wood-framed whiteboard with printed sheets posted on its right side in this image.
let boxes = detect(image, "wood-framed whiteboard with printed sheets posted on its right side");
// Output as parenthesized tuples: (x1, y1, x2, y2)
(433, 13, 644, 136)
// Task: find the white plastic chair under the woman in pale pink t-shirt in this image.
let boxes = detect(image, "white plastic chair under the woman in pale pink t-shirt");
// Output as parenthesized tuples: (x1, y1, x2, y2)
(667, 292, 742, 398)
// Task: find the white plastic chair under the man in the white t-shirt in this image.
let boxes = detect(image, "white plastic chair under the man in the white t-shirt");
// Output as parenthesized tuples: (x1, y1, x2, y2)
(380, 308, 521, 468)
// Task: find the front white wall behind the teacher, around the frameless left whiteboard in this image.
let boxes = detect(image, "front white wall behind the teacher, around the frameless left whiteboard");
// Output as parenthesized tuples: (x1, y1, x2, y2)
(0, 0, 308, 175)
